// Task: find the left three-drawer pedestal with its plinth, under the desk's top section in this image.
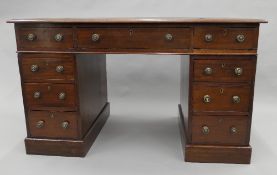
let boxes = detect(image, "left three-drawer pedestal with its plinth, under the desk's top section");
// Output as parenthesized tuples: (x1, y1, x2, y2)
(18, 53, 109, 157)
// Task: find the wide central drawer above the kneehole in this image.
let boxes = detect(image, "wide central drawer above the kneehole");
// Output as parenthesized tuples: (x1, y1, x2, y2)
(77, 28, 192, 50)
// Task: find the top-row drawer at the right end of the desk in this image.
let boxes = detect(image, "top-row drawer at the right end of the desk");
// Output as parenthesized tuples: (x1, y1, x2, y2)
(193, 26, 258, 49)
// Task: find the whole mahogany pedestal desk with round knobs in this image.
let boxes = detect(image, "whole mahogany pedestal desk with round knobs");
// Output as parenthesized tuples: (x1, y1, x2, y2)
(8, 18, 266, 163)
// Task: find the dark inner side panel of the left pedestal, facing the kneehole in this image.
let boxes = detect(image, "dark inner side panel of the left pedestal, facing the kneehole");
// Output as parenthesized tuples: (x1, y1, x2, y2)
(76, 54, 107, 135)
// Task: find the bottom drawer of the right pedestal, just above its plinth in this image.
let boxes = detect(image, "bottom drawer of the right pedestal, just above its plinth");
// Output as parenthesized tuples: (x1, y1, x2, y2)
(191, 116, 250, 145)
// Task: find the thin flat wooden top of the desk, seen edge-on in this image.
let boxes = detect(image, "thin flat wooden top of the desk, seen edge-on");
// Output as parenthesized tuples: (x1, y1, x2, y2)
(7, 17, 267, 24)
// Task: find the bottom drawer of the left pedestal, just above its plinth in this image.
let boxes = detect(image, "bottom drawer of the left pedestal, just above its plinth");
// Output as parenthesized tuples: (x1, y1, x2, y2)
(28, 111, 79, 139)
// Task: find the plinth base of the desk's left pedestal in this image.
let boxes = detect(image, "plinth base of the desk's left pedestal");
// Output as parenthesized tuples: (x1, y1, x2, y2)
(25, 103, 110, 157)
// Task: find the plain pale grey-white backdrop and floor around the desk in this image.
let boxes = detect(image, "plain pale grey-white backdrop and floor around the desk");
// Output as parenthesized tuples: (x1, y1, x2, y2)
(0, 0, 277, 175)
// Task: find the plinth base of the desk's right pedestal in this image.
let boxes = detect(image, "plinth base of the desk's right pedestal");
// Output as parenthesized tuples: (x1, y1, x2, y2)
(179, 105, 252, 164)
